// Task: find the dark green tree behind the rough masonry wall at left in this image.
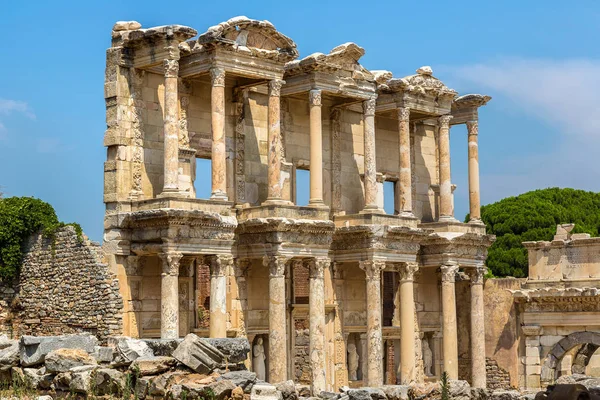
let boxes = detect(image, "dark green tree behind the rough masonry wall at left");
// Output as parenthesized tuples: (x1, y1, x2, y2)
(0, 197, 81, 281)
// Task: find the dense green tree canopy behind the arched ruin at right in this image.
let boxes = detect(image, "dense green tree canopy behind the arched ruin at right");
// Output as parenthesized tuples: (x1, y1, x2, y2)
(467, 188, 600, 278)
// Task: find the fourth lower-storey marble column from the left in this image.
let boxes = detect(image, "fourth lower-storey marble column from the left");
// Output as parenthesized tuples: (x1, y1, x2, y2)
(308, 258, 329, 396)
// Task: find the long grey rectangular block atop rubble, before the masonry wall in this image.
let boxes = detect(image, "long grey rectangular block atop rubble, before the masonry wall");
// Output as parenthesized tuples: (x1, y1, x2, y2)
(19, 334, 98, 367)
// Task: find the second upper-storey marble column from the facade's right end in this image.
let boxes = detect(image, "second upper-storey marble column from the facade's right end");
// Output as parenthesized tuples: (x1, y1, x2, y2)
(438, 115, 455, 221)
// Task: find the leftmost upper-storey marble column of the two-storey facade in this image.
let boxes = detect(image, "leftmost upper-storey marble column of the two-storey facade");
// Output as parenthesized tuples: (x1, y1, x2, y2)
(162, 60, 179, 195)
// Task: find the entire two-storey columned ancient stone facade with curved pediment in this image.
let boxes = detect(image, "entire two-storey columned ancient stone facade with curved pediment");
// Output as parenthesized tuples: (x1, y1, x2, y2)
(103, 17, 493, 393)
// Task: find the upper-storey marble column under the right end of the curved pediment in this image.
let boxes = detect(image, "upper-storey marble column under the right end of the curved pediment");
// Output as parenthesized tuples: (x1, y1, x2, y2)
(265, 79, 287, 204)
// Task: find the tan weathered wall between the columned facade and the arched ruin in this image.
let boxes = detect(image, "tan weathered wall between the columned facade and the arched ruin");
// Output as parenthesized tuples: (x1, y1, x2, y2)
(483, 278, 525, 387)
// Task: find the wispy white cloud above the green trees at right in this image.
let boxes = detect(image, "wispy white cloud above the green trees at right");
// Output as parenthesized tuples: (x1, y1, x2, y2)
(442, 59, 600, 204)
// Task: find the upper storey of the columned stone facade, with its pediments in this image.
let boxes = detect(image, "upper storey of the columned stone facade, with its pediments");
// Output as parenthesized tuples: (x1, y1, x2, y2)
(104, 17, 489, 228)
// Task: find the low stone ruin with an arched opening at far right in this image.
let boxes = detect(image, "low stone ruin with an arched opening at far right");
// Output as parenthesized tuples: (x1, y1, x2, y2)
(511, 224, 600, 389)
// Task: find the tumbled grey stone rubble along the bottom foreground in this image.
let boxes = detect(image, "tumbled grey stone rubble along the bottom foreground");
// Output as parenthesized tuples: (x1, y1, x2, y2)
(0, 334, 600, 400)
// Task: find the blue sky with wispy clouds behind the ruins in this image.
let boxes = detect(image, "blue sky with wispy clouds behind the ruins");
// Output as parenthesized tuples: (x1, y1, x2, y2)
(0, 0, 600, 240)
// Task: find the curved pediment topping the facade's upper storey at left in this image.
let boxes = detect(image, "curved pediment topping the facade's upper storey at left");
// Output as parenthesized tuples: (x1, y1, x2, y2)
(197, 16, 298, 61)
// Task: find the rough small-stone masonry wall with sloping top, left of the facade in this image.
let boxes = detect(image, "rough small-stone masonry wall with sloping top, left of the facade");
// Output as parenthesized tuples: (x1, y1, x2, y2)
(0, 226, 123, 340)
